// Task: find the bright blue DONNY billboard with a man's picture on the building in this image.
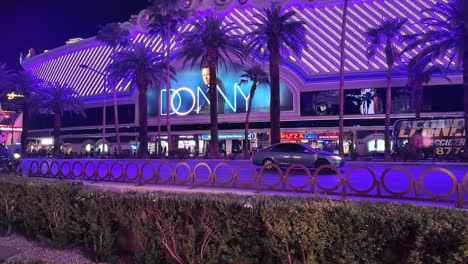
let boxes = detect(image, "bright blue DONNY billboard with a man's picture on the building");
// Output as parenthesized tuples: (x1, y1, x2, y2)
(147, 64, 293, 117)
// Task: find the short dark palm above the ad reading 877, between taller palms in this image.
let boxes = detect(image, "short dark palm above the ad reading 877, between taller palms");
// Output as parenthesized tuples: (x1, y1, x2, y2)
(408, 55, 442, 118)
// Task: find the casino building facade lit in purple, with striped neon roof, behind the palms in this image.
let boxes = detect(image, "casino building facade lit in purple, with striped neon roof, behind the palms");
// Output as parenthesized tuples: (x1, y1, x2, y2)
(22, 0, 463, 155)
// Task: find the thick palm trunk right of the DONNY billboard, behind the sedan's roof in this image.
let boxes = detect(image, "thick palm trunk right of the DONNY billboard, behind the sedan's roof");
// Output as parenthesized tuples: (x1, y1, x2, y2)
(270, 45, 281, 144)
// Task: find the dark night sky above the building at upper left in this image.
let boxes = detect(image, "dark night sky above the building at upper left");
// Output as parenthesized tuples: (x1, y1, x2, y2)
(0, 0, 149, 68)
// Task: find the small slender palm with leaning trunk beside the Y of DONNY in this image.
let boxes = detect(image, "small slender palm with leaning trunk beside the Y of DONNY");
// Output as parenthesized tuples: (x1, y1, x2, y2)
(239, 65, 270, 158)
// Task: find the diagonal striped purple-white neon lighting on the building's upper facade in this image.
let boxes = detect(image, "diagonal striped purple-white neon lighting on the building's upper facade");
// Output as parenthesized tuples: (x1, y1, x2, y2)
(24, 0, 450, 96)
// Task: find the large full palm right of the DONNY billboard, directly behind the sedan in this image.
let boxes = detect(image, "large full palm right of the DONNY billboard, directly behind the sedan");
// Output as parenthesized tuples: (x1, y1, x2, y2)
(247, 5, 306, 144)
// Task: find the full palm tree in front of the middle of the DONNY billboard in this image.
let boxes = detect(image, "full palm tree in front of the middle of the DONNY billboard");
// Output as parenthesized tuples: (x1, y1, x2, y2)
(179, 14, 244, 158)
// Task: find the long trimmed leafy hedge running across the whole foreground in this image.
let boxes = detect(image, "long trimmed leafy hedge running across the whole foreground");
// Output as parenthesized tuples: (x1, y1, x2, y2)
(0, 177, 468, 263)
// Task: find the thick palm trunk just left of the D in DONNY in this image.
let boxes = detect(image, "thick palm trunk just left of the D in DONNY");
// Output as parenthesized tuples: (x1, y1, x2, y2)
(137, 77, 148, 158)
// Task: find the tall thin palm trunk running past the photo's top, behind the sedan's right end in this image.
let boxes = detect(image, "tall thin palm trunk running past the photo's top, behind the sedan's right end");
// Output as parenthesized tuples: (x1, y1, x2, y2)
(338, 0, 348, 156)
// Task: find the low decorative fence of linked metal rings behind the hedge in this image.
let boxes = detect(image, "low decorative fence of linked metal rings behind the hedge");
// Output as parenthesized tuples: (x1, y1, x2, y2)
(21, 159, 468, 208)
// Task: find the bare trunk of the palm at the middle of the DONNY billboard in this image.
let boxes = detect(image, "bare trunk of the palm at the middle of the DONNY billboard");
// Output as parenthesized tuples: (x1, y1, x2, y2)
(208, 59, 220, 158)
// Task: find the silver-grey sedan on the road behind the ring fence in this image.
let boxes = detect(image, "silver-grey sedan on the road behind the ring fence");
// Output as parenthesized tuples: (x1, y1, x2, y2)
(252, 143, 345, 168)
